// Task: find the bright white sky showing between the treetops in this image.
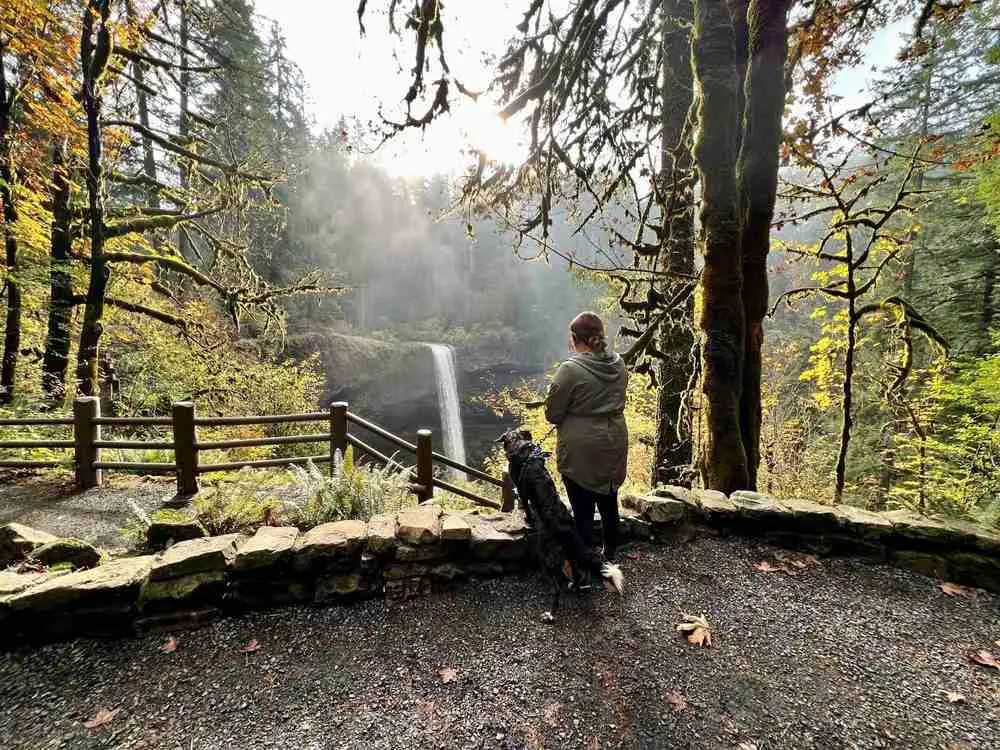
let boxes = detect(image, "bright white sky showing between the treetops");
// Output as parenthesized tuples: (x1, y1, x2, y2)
(256, 0, 908, 177)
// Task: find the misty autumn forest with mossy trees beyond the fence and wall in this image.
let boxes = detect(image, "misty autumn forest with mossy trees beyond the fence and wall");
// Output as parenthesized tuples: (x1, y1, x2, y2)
(0, 0, 1000, 527)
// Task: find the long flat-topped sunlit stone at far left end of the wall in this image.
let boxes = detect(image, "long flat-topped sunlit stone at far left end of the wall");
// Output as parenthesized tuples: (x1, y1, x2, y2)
(7, 555, 155, 614)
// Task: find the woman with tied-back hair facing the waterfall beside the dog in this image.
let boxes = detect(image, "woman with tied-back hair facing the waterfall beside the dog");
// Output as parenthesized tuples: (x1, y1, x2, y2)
(545, 312, 628, 561)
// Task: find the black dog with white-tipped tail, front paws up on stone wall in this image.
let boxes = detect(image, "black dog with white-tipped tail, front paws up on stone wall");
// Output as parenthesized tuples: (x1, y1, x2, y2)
(497, 430, 625, 611)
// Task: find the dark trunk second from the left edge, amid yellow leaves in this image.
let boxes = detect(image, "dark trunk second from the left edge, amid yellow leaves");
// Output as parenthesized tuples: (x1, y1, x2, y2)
(42, 138, 73, 407)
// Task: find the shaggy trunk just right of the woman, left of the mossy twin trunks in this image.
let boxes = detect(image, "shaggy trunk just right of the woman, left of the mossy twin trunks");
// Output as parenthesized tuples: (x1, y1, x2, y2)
(652, 0, 694, 486)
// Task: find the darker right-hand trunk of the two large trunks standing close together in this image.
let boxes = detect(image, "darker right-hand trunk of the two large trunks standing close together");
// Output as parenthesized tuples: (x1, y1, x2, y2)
(739, 0, 790, 489)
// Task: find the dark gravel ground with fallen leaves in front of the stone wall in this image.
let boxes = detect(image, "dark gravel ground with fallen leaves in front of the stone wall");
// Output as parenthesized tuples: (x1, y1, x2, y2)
(0, 537, 1000, 750)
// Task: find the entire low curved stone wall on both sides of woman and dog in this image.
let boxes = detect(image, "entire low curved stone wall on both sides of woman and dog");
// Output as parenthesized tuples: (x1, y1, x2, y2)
(0, 487, 1000, 648)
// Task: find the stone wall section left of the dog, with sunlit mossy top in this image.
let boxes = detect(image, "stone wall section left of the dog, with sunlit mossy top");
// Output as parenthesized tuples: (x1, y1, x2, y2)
(0, 505, 548, 647)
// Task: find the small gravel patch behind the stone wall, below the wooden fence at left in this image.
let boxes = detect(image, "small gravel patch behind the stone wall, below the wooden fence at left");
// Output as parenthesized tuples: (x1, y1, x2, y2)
(0, 477, 176, 551)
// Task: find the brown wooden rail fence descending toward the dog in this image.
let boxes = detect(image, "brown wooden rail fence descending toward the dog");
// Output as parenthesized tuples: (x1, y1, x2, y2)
(0, 396, 514, 511)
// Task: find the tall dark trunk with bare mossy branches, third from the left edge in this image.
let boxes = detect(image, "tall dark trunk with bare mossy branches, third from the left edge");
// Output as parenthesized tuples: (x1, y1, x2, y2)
(76, 0, 111, 396)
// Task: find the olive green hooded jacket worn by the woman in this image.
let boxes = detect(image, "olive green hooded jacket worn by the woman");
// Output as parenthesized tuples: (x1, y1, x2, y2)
(545, 352, 628, 494)
